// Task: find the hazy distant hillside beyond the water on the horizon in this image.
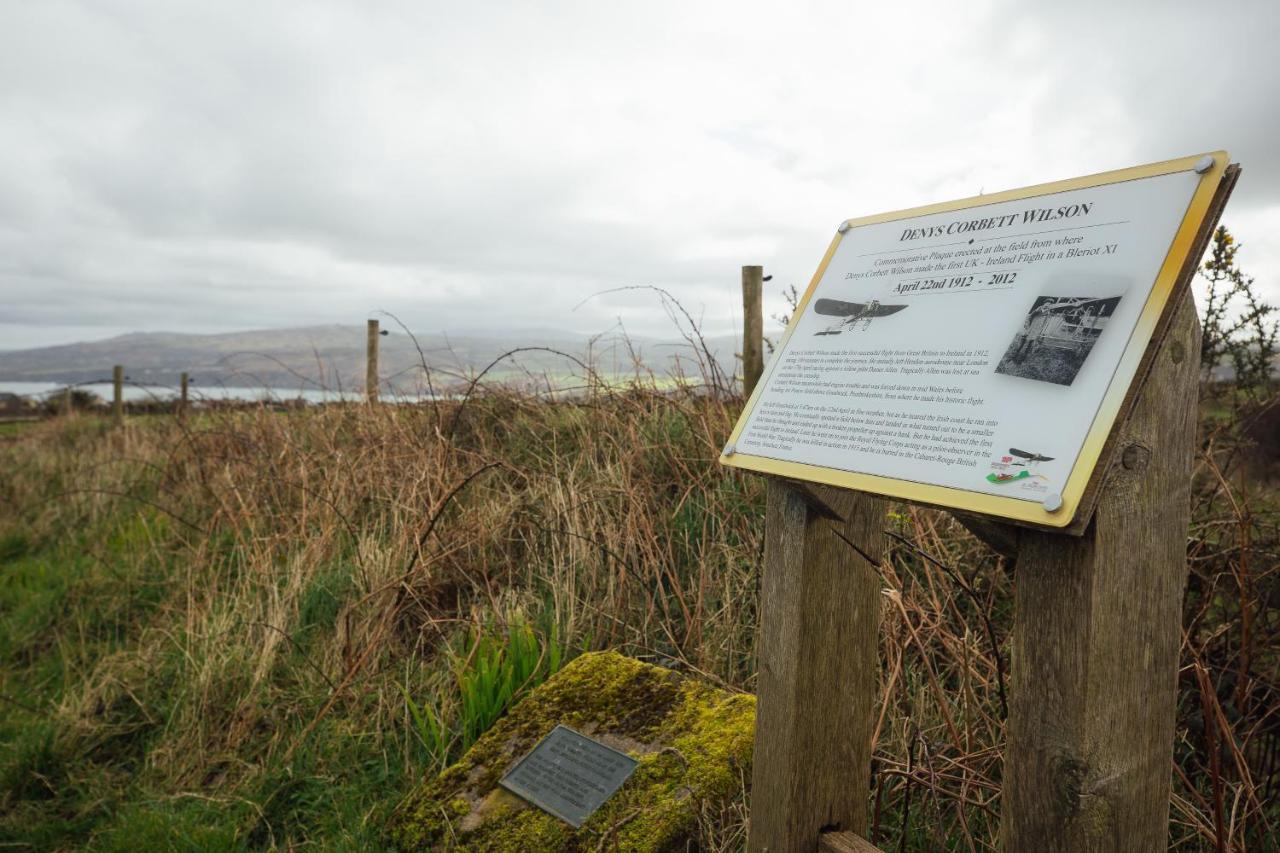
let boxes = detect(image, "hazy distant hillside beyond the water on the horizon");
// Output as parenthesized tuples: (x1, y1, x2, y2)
(0, 325, 739, 391)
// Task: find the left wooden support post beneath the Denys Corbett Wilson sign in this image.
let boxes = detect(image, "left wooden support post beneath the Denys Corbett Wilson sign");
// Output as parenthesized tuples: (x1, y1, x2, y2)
(749, 478, 884, 853)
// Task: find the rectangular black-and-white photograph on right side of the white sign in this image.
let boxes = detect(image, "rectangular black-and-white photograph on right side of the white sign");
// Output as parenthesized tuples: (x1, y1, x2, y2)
(996, 296, 1120, 386)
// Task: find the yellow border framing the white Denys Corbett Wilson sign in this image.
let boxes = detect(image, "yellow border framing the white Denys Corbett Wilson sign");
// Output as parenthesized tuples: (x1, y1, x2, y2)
(719, 151, 1229, 528)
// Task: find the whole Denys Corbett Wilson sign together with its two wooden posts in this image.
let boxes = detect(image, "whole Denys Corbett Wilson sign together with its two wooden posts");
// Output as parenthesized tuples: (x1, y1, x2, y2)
(721, 152, 1239, 852)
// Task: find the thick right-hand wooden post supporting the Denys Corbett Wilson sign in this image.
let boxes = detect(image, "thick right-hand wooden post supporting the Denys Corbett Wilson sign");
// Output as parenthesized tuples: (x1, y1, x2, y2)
(1001, 293, 1199, 853)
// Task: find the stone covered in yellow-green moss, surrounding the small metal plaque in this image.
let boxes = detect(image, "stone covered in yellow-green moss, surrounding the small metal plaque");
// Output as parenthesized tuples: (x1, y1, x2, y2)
(389, 652, 755, 853)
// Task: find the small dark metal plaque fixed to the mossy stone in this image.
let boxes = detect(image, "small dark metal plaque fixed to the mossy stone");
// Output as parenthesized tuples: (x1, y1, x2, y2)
(498, 726, 637, 829)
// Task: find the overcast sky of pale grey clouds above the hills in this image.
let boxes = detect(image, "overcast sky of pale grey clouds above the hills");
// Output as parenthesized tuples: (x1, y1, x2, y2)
(0, 0, 1280, 348)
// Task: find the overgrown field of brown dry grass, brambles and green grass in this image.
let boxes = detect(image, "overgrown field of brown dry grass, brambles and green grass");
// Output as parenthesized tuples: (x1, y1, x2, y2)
(0, 386, 1280, 850)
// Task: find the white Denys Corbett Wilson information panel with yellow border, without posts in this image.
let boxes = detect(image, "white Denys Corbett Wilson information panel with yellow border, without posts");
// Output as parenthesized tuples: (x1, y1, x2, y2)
(721, 151, 1228, 528)
